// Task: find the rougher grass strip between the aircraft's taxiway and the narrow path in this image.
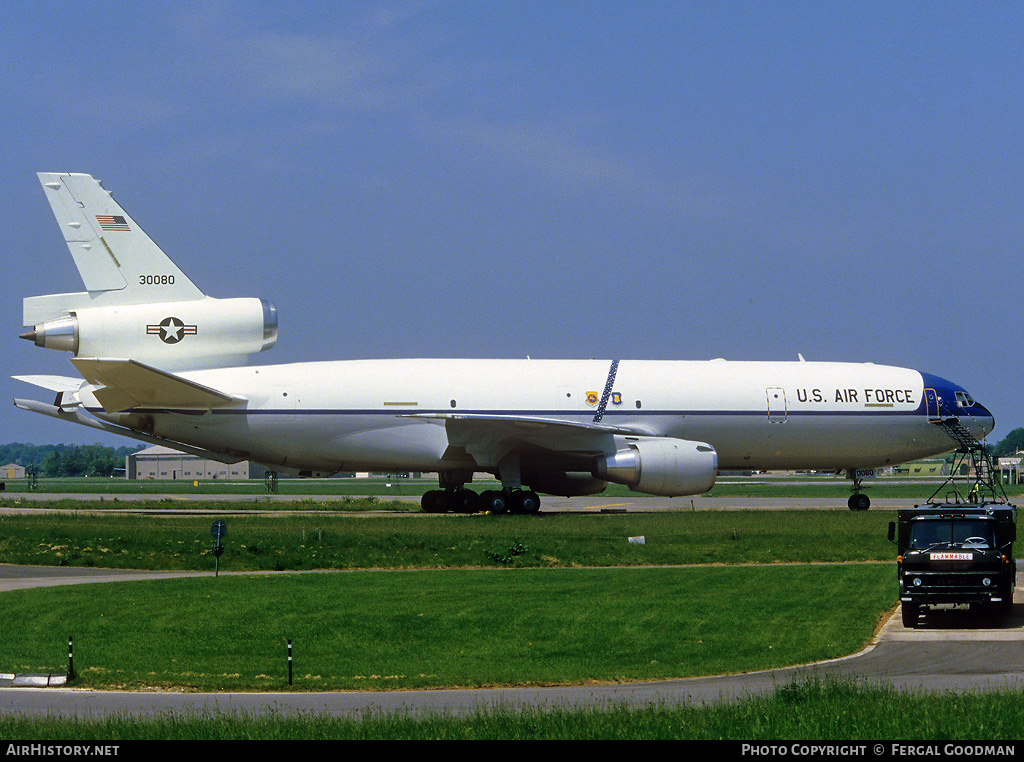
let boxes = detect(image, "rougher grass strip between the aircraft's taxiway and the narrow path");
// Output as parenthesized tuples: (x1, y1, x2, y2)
(0, 504, 895, 570)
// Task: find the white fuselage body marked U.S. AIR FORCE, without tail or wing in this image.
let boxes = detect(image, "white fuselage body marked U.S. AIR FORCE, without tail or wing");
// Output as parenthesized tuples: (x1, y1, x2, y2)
(87, 359, 974, 473)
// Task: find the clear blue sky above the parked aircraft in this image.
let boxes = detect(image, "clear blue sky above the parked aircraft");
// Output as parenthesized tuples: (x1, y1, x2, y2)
(0, 0, 1024, 443)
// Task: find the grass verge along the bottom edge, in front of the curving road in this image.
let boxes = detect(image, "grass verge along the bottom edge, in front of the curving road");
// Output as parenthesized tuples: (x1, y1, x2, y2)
(0, 683, 1024, 737)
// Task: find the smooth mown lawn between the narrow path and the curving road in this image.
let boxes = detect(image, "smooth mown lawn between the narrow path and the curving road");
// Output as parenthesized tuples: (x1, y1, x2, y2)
(0, 564, 894, 691)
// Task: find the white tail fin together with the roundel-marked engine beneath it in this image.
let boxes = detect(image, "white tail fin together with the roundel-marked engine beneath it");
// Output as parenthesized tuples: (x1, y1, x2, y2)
(22, 172, 278, 372)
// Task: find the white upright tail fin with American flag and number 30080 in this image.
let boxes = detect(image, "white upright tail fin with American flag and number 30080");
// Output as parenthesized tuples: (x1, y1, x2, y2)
(23, 172, 204, 326)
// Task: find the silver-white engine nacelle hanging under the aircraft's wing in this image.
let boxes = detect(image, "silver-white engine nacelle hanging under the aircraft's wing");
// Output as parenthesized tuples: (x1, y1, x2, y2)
(594, 436, 718, 498)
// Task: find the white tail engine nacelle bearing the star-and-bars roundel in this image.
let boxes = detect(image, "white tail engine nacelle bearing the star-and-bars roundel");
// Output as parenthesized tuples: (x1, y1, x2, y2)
(22, 297, 278, 370)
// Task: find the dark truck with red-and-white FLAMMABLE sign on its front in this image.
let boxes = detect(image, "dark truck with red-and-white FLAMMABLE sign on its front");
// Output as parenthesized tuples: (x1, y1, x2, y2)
(889, 503, 1017, 627)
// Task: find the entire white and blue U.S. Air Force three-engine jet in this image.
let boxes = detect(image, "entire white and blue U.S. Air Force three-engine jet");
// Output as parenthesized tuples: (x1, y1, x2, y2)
(14, 173, 994, 513)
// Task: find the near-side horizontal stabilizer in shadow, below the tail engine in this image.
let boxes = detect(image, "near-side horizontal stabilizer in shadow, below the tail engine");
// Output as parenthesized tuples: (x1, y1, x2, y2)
(71, 357, 246, 413)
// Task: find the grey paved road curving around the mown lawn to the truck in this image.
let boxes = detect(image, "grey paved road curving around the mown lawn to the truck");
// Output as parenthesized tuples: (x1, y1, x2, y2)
(0, 565, 1024, 718)
